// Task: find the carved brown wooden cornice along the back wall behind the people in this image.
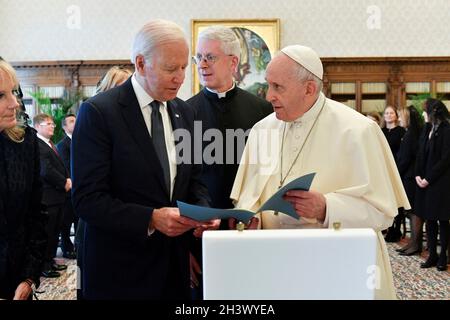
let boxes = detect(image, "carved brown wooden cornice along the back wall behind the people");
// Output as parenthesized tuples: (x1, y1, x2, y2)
(12, 57, 450, 112)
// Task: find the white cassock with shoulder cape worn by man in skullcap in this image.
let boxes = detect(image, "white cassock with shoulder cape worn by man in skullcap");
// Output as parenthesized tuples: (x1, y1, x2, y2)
(231, 93, 410, 299)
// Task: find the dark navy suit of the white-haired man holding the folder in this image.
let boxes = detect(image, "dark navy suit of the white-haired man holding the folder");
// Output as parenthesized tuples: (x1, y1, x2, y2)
(72, 79, 208, 299)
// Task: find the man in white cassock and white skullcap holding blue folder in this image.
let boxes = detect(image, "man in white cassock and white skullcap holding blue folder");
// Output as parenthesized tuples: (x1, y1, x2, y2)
(231, 45, 410, 299)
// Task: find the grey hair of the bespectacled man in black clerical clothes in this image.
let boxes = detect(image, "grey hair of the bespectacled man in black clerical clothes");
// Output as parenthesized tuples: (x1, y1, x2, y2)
(198, 25, 241, 59)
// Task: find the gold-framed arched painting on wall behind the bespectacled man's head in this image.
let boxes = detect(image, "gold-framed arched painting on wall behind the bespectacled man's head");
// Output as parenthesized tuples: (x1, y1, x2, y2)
(191, 19, 280, 98)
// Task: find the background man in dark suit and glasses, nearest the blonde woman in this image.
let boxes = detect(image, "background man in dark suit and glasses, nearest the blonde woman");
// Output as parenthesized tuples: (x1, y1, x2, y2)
(33, 113, 72, 278)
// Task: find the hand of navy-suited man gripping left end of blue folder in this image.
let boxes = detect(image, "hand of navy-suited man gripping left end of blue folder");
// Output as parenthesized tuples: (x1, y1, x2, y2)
(150, 207, 201, 237)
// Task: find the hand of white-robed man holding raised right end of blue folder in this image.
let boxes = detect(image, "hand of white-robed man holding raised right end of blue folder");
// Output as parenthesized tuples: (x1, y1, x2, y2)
(283, 190, 327, 222)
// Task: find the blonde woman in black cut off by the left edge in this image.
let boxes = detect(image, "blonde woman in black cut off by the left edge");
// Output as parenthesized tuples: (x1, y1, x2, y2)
(0, 60, 47, 300)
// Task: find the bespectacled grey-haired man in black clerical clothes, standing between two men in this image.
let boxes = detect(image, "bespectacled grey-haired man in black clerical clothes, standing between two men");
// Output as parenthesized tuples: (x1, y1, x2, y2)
(187, 26, 273, 298)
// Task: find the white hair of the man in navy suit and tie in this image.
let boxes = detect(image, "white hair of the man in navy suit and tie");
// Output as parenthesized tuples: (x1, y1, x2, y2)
(131, 19, 187, 63)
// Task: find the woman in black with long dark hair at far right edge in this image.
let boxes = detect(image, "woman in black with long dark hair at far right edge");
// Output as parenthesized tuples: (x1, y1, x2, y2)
(416, 98, 450, 271)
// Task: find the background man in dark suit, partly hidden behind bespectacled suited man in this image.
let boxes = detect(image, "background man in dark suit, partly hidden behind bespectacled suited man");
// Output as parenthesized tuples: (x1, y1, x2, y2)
(56, 113, 78, 259)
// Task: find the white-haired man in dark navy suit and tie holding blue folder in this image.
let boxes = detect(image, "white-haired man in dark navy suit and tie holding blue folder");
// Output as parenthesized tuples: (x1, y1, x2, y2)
(72, 20, 214, 299)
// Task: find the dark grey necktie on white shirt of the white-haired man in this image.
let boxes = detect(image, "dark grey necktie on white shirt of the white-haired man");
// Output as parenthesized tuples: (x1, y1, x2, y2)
(150, 100, 170, 194)
